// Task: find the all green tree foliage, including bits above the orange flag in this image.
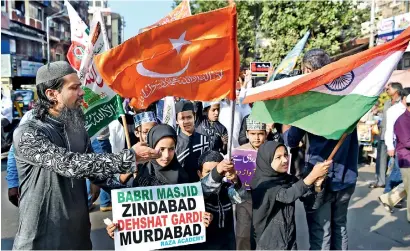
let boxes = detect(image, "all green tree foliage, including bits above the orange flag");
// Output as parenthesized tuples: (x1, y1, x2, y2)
(174, 0, 369, 66)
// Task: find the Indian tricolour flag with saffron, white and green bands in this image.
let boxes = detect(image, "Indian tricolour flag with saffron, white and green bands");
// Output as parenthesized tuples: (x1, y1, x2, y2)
(243, 28, 410, 140)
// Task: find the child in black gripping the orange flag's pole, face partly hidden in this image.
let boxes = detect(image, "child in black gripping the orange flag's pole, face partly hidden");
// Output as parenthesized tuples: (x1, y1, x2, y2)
(198, 151, 245, 250)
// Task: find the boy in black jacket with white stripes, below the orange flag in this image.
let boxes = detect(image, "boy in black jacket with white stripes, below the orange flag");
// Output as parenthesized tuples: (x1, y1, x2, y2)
(175, 100, 209, 182)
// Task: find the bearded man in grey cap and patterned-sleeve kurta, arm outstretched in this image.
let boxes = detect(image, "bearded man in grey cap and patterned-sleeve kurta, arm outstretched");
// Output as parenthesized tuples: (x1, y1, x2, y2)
(13, 61, 160, 250)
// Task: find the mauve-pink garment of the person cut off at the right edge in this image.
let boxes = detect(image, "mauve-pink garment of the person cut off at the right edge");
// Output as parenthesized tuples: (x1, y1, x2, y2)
(394, 109, 410, 168)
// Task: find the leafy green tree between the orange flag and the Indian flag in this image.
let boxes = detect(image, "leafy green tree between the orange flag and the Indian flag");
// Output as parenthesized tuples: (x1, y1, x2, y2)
(260, 0, 369, 65)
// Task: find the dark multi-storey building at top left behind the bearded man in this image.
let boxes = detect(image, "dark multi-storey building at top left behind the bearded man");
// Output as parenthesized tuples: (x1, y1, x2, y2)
(1, 0, 88, 89)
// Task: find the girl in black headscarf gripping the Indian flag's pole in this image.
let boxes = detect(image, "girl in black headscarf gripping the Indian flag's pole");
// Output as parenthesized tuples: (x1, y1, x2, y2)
(251, 141, 331, 250)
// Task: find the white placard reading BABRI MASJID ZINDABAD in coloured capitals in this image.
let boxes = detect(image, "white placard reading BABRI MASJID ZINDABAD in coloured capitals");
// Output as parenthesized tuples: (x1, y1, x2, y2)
(111, 182, 206, 250)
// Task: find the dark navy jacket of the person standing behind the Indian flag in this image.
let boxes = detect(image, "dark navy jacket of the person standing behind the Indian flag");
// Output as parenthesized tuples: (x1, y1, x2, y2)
(284, 126, 359, 191)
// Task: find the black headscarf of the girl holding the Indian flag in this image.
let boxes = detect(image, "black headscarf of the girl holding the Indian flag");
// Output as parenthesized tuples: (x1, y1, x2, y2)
(251, 141, 294, 240)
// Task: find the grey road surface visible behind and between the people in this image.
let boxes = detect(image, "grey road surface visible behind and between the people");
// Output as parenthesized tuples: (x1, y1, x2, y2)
(1, 160, 410, 250)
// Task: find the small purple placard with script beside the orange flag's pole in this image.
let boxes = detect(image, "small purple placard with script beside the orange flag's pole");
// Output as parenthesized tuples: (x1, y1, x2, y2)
(232, 149, 257, 190)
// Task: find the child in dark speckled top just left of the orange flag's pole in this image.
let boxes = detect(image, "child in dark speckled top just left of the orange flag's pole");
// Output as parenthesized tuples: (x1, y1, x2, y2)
(196, 102, 228, 154)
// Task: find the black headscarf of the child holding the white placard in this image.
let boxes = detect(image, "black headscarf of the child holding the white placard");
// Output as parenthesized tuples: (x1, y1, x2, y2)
(147, 125, 189, 185)
